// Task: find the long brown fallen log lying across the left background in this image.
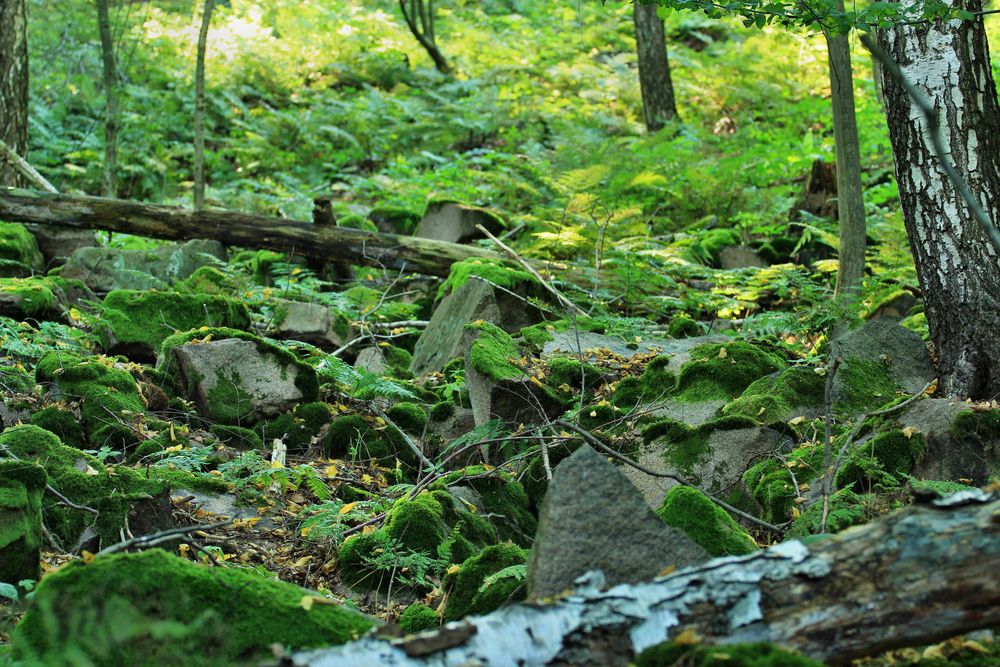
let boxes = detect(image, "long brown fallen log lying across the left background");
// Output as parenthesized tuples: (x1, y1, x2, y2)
(0, 188, 500, 276)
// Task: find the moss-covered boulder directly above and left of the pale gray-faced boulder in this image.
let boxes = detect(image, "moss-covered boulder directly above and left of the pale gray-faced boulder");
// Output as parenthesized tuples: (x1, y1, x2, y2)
(95, 290, 250, 361)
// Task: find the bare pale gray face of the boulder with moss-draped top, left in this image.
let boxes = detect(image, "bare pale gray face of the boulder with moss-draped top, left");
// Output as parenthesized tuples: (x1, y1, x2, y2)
(173, 338, 311, 424)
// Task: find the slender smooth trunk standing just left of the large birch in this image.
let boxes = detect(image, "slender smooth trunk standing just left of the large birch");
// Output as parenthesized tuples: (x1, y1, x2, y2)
(826, 12, 867, 295)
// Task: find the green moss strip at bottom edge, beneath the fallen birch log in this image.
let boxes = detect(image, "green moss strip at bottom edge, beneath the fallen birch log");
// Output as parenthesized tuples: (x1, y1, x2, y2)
(633, 642, 823, 667)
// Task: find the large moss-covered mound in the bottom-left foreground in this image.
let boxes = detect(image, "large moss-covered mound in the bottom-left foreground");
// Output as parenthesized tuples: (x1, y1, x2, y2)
(13, 549, 372, 665)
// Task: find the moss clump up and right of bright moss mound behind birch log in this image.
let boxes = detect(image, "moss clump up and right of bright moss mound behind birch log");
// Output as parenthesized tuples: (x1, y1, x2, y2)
(743, 445, 823, 523)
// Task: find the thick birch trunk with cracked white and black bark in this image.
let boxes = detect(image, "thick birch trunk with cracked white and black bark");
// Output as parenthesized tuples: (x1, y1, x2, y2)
(879, 0, 1000, 398)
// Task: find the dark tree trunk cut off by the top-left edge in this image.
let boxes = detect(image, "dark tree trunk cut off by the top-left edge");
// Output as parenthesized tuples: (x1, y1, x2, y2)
(0, 0, 28, 186)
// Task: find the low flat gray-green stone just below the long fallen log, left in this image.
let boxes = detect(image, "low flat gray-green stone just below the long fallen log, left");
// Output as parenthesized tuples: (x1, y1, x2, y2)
(59, 239, 226, 292)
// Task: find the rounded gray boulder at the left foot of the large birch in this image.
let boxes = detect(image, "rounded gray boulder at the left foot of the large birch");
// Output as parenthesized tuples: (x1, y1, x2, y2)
(830, 318, 935, 396)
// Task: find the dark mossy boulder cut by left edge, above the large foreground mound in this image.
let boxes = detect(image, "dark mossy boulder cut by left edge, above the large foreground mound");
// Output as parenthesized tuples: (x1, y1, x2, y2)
(0, 459, 48, 585)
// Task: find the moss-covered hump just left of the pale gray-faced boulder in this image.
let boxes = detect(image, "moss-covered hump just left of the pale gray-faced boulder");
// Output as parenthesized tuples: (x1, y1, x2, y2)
(35, 352, 146, 449)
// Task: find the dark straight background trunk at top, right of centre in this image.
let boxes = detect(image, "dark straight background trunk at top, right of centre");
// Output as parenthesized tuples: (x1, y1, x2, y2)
(632, 0, 677, 132)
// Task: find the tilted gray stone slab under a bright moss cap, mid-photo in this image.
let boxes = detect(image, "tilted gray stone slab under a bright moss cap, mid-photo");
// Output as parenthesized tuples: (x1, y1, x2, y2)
(410, 278, 540, 375)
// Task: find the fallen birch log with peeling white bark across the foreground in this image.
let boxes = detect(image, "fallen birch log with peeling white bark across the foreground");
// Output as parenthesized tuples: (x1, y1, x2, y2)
(291, 491, 1000, 667)
